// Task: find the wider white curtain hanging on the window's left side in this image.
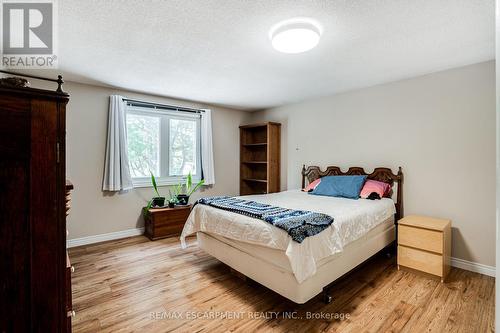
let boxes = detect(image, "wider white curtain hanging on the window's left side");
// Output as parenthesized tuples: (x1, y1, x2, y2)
(102, 95, 133, 191)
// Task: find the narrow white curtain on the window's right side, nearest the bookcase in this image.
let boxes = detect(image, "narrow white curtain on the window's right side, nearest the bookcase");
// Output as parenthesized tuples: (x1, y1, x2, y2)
(201, 110, 215, 185)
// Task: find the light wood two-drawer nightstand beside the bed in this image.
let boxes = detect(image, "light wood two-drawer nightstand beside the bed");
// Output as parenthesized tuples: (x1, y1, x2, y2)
(398, 215, 451, 282)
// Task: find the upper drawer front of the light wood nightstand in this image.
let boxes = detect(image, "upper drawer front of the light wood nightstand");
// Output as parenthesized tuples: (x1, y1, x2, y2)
(398, 225, 443, 253)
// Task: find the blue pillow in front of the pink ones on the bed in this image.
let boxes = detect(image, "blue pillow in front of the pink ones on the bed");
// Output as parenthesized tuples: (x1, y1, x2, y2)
(310, 176, 366, 199)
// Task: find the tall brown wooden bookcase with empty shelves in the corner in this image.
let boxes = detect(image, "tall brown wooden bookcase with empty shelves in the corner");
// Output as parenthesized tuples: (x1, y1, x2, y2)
(240, 122, 281, 195)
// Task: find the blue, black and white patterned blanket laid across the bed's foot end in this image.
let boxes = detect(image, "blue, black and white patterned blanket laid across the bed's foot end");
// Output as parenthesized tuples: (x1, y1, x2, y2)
(196, 196, 333, 243)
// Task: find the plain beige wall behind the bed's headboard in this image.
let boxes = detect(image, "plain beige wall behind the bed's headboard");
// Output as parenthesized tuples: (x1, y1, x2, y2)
(253, 61, 495, 266)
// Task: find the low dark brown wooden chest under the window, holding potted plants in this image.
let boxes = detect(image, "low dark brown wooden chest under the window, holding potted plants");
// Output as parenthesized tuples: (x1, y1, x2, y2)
(144, 205, 192, 240)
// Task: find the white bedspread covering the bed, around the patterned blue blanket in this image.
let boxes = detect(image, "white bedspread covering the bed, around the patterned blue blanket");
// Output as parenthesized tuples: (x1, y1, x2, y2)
(181, 190, 396, 283)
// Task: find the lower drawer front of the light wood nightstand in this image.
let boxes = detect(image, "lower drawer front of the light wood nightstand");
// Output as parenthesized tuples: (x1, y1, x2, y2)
(398, 245, 443, 277)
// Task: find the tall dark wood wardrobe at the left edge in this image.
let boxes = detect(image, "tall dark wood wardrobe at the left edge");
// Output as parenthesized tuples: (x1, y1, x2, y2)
(0, 73, 73, 332)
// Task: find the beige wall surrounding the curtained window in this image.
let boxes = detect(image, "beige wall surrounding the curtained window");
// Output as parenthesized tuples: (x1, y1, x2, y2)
(58, 82, 249, 239)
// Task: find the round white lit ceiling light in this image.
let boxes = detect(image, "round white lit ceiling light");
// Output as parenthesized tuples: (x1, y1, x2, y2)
(269, 17, 322, 53)
